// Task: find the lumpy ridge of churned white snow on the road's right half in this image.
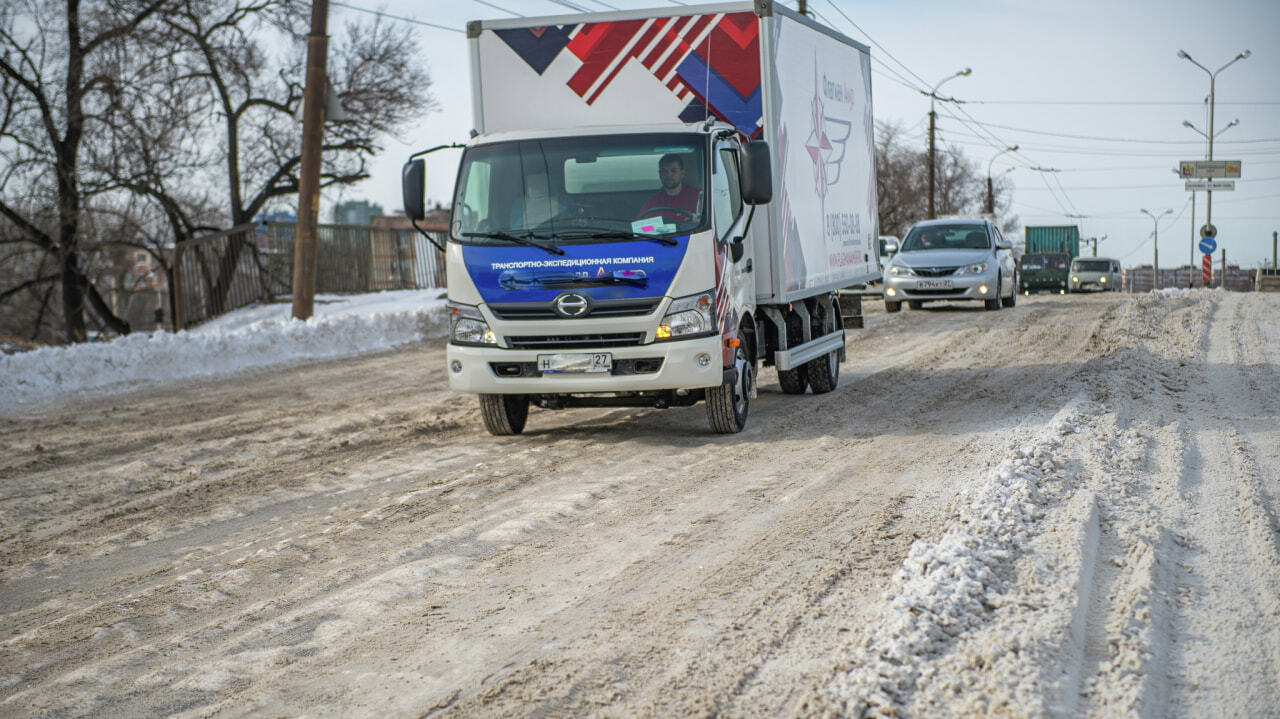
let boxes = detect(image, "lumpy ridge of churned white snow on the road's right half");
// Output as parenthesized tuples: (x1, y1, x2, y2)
(826, 402, 1100, 716)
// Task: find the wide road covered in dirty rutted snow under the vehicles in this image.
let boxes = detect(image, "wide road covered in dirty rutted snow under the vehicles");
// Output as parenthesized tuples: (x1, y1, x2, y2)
(0, 292, 1280, 716)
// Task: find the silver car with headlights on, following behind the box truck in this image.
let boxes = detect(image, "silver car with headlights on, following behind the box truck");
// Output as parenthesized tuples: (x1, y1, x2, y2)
(884, 219, 1018, 312)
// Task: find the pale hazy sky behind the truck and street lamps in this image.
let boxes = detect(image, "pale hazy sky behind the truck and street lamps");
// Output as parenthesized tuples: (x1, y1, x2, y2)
(325, 0, 1280, 267)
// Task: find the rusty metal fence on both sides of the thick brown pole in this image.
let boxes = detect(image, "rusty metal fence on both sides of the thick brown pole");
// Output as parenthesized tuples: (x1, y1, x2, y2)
(174, 223, 444, 329)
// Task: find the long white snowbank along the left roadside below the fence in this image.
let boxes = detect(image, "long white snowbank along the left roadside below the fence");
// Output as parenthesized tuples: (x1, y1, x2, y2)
(0, 289, 447, 412)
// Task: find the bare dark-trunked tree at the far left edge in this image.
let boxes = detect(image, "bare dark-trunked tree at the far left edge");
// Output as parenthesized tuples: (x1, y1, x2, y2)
(0, 0, 168, 342)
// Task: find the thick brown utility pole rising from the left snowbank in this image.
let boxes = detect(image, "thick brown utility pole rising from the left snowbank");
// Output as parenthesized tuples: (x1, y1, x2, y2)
(293, 0, 329, 320)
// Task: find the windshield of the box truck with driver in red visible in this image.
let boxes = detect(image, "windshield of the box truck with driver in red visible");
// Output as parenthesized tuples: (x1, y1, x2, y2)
(451, 134, 709, 246)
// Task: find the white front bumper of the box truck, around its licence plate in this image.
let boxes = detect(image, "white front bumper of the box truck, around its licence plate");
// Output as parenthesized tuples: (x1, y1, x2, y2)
(447, 335, 724, 394)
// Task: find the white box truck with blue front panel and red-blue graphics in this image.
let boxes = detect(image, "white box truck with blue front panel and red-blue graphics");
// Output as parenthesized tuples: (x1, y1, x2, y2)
(403, 0, 879, 435)
